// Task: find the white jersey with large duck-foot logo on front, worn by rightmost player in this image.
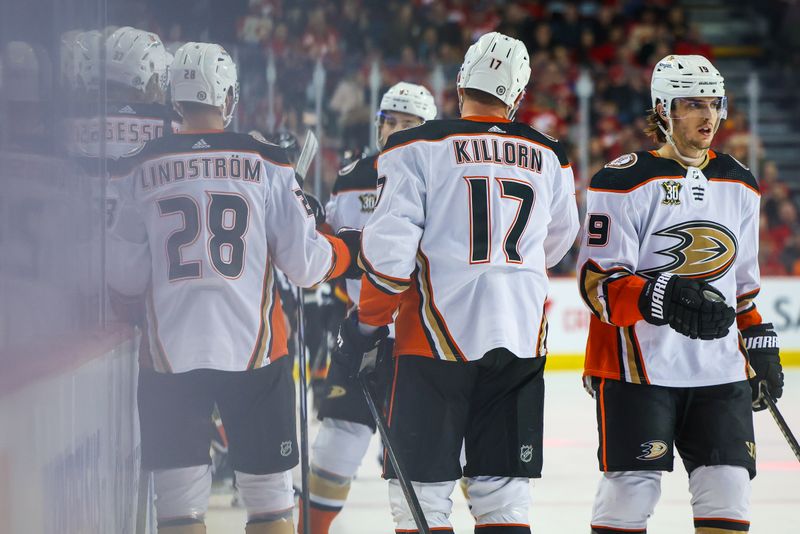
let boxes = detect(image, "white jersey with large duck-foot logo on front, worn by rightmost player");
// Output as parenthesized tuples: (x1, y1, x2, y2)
(578, 151, 761, 387)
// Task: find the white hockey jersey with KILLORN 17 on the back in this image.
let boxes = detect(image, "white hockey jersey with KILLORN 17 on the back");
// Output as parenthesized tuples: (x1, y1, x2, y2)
(359, 117, 579, 361)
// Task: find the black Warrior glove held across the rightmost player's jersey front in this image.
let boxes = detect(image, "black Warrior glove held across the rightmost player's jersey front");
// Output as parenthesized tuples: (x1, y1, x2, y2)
(639, 273, 736, 339)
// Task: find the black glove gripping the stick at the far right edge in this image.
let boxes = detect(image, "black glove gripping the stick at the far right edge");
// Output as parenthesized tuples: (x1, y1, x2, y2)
(742, 323, 783, 412)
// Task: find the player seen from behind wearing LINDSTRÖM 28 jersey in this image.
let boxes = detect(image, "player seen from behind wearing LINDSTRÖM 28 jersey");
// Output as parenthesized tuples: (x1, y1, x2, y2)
(109, 43, 350, 534)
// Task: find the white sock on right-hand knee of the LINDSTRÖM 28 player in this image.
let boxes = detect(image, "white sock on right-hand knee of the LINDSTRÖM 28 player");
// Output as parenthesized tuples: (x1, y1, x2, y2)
(235, 471, 294, 522)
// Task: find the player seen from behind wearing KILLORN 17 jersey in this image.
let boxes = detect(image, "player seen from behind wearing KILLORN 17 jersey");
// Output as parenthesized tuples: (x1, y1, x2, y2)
(335, 32, 578, 534)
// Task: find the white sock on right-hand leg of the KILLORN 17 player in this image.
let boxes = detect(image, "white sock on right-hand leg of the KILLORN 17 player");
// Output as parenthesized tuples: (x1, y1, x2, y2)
(467, 476, 530, 525)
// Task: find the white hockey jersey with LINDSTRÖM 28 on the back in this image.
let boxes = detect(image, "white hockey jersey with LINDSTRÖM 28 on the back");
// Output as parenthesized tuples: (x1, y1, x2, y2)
(108, 133, 350, 373)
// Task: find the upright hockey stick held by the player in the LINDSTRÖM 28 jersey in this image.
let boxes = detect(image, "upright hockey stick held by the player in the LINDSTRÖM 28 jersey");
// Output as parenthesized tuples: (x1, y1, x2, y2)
(295, 130, 319, 532)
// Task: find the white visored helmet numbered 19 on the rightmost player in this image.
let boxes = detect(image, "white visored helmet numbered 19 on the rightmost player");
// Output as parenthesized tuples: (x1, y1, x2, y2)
(650, 55, 728, 119)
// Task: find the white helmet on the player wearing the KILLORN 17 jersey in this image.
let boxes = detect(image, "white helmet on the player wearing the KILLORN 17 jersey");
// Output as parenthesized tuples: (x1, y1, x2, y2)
(456, 32, 531, 107)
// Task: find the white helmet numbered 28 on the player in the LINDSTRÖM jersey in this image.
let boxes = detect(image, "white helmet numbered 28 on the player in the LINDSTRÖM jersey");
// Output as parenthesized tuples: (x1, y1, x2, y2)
(169, 43, 239, 126)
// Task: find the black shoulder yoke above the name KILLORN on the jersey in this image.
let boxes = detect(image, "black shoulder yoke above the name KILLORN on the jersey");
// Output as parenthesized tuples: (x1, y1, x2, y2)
(384, 117, 569, 166)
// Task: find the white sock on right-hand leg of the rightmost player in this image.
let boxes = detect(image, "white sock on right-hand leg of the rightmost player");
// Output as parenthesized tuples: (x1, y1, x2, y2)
(689, 465, 752, 530)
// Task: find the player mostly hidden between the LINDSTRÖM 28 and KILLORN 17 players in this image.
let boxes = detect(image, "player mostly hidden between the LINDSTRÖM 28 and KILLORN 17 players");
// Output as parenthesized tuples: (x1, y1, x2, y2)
(300, 82, 436, 534)
